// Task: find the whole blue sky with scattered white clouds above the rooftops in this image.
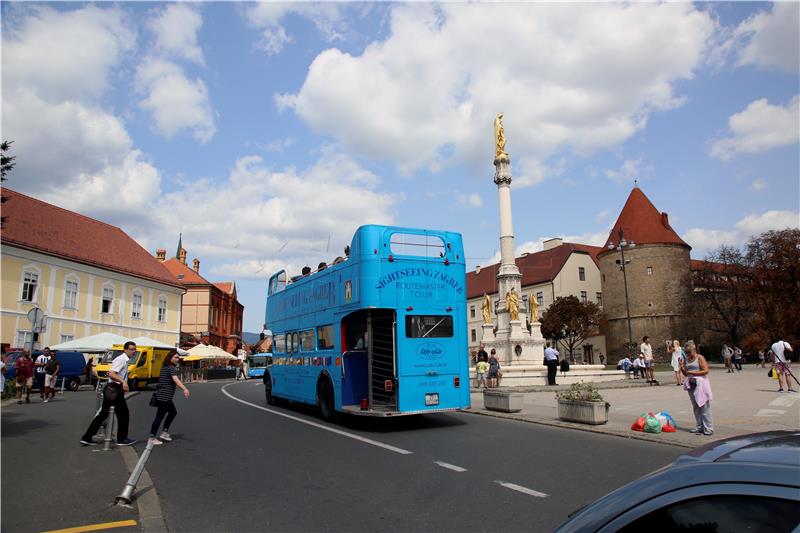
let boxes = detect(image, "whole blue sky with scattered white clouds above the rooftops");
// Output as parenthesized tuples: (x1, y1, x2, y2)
(2, 2, 800, 331)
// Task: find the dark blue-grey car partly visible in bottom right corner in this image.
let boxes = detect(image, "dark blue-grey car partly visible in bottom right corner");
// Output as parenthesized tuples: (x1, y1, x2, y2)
(556, 431, 800, 533)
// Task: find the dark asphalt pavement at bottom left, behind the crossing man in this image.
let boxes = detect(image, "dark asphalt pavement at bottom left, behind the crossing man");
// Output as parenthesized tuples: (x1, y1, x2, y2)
(1, 388, 143, 532)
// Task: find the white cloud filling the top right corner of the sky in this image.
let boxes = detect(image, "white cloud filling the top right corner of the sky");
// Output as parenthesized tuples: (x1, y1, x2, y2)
(729, 2, 800, 73)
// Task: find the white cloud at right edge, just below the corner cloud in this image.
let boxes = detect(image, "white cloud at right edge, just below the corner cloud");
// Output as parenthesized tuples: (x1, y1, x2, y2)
(710, 96, 800, 161)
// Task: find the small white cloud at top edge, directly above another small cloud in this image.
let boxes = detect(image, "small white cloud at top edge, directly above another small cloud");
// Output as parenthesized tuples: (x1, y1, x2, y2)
(147, 3, 205, 65)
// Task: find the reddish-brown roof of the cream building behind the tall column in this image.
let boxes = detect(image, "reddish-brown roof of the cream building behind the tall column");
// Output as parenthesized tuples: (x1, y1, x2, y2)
(467, 243, 602, 299)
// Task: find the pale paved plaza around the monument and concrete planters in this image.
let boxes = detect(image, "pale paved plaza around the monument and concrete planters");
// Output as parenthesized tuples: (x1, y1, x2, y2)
(467, 365, 800, 448)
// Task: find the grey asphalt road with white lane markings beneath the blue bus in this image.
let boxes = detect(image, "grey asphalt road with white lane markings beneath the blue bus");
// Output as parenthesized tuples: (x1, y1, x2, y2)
(130, 381, 685, 532)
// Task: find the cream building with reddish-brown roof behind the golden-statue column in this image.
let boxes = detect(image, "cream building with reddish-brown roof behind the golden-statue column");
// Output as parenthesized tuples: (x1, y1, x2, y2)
(467, 239, 607, 364)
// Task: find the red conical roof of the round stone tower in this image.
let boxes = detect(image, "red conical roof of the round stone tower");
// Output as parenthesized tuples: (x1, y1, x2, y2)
(603, 187, 690, 249)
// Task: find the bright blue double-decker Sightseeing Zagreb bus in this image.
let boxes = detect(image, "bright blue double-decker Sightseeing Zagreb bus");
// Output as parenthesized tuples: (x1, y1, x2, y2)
(264, 225, 470, 420)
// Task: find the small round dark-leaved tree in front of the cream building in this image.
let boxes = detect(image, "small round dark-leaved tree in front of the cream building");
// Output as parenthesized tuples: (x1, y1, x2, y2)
(542, 296, 604, 362)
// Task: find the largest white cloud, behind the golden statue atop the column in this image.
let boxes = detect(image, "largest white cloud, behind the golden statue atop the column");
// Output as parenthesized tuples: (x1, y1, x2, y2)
(275, 3, 714, 175)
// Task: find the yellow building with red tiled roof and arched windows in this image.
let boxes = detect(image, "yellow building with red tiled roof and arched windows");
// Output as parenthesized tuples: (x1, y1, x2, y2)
(0, 188, 185, 348)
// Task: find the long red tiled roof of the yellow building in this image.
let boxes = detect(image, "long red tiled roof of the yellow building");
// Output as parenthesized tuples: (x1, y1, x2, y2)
(0, 187, 182, 287)
